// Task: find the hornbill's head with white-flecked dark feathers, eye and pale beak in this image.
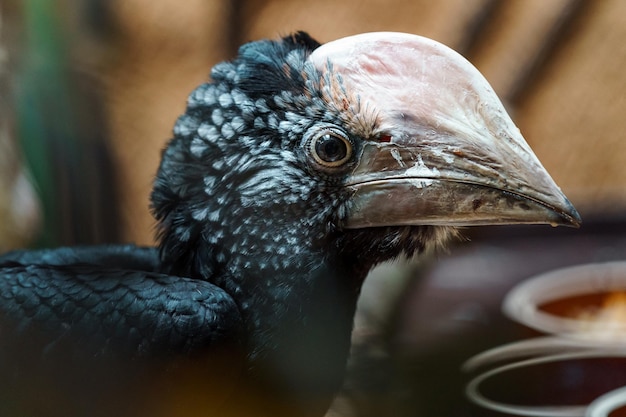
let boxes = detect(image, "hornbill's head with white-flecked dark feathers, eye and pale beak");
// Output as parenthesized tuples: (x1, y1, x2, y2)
(152, 32, 580, 277)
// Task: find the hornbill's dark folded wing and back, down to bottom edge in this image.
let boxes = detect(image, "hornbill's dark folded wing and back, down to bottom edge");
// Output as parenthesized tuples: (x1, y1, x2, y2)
(0, 246, 243, 416)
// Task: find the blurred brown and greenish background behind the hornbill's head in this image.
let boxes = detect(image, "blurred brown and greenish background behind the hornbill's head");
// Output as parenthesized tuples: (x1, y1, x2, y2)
(0, 0, 626, 246)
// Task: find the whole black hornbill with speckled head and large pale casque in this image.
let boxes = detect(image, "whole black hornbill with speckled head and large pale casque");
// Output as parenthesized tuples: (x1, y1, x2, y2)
(0, 32, 580, 416)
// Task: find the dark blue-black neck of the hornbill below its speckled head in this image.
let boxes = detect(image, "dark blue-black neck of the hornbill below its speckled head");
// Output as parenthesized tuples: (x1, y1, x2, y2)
(207, 234, 365, 402)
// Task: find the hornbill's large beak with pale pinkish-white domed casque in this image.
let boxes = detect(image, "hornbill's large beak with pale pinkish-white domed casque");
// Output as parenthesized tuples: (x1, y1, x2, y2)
(309, 32, 581, 228)
